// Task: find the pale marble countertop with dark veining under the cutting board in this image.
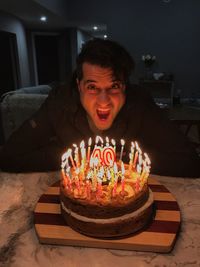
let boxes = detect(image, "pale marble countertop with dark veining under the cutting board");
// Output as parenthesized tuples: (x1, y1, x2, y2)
(0, 172, 200, 267)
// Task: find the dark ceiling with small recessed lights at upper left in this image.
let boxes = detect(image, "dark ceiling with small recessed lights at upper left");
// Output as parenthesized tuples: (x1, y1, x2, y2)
(0, 0, 107, 37)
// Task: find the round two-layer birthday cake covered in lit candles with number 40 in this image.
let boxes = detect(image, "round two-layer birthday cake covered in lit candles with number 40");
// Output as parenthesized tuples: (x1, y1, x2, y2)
(60, 137, 153, 238)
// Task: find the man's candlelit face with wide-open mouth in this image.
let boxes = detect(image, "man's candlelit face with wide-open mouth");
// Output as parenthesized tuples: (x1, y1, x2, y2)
(77, 63, 125, 130)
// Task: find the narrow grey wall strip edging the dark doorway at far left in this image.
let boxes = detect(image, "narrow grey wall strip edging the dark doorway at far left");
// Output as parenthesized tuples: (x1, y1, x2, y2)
(0, 11, 30, 87)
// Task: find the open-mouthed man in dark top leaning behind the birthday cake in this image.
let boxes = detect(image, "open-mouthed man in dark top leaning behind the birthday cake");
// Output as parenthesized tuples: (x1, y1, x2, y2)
(0, 39, 200, 177)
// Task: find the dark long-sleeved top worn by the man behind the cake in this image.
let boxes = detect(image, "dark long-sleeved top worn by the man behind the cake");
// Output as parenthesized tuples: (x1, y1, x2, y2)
(0, 86, 200, 177)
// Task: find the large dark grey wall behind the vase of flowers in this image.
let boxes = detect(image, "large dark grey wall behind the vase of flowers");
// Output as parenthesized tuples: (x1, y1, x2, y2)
(69, 0, 200, 97)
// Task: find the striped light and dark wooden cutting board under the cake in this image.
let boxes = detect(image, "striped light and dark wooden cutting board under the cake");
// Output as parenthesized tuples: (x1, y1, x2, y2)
(34, 178, 181, 253)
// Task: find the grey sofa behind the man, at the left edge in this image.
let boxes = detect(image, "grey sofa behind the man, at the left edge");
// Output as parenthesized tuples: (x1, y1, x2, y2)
(0, 85, 52, 143)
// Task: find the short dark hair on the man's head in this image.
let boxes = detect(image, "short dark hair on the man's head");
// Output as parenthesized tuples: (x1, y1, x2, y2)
(76, 38, 135, 83)
